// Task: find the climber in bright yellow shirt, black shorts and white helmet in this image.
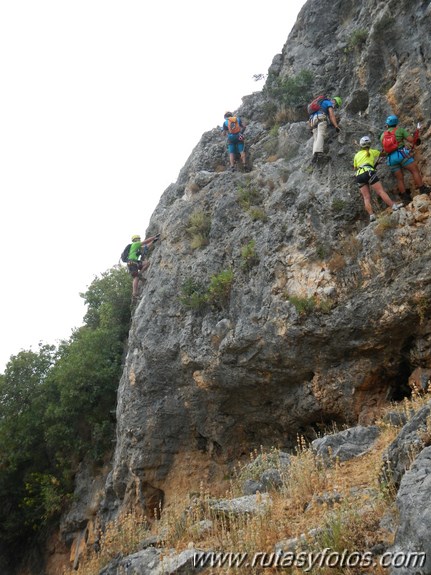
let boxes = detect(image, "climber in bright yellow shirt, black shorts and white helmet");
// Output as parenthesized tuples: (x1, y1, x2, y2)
(353, 136, 403, 222)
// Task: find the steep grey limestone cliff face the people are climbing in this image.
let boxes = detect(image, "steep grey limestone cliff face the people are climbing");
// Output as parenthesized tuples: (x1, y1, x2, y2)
(103, 0, 431, 512)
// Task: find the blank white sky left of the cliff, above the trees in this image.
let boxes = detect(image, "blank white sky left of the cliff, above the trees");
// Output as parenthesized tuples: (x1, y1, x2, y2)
(0, 0, 305, 372)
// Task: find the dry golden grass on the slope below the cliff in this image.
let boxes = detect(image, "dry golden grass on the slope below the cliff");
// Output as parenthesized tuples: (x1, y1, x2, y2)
(65, 393, 431, 575)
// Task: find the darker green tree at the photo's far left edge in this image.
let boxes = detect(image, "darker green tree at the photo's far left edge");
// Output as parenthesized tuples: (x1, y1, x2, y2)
(0, 345, 56, 549)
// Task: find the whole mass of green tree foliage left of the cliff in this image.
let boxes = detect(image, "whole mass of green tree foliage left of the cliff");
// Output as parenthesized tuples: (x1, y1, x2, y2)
(0, 267, 131, 554)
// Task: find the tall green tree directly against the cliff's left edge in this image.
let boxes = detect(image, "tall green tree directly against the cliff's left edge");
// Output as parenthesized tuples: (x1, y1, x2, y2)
(45, 266, 130, 477)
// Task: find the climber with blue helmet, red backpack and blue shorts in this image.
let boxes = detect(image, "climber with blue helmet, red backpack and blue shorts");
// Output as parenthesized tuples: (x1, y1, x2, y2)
(380, 115, 431, 206)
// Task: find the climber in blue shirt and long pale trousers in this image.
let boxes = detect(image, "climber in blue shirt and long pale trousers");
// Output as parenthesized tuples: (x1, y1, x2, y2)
(307, 96, 342, 163)
